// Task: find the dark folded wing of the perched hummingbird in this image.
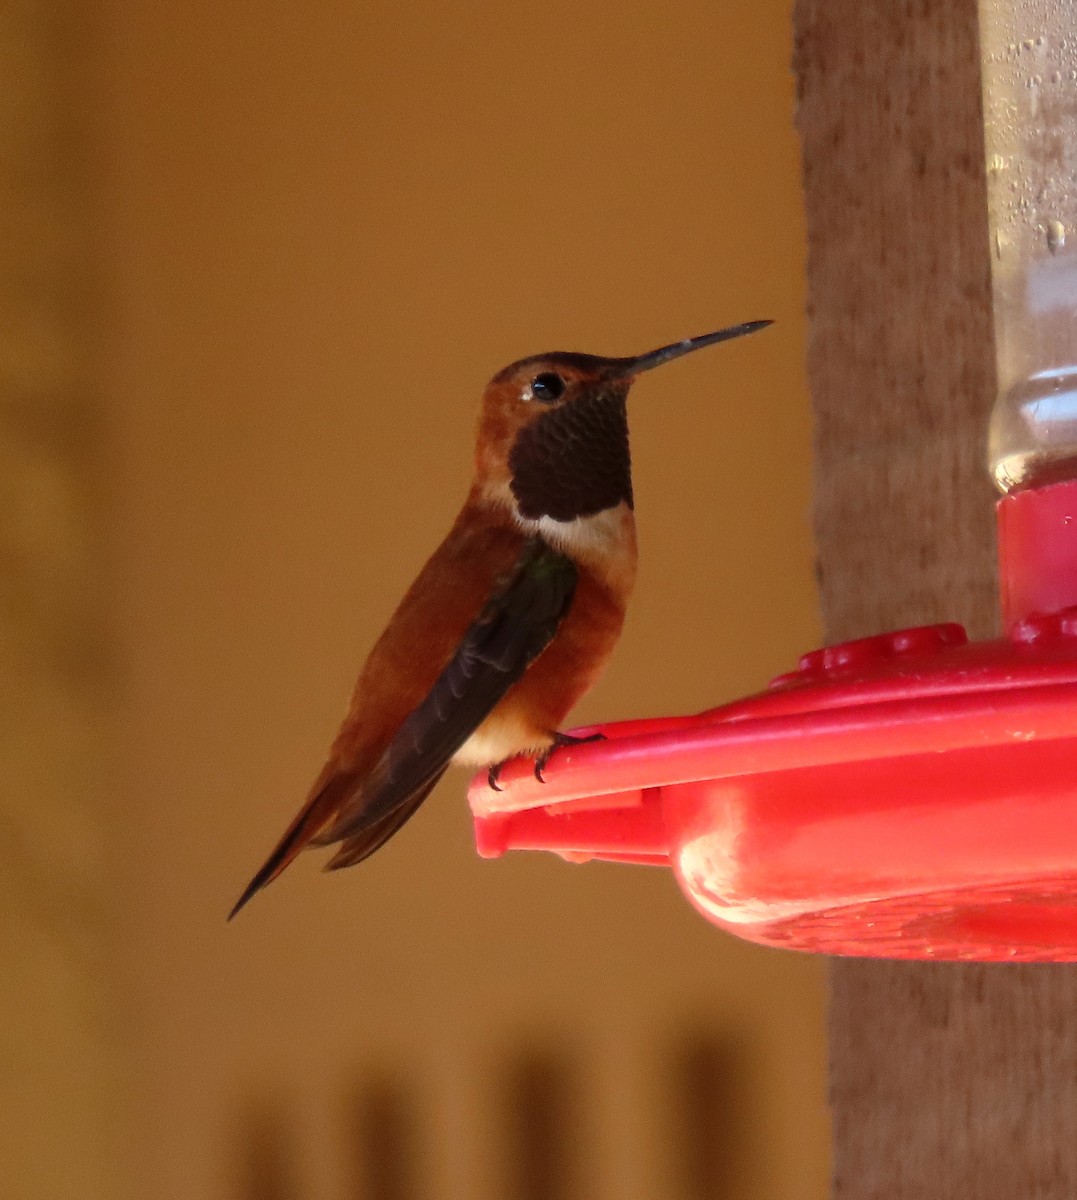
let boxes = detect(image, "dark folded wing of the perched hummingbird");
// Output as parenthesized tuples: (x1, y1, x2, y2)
(315, 538, 577, 870)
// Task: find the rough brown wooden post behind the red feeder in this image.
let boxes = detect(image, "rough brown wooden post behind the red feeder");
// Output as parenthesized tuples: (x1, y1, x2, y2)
(795, 0, 1077, 1200)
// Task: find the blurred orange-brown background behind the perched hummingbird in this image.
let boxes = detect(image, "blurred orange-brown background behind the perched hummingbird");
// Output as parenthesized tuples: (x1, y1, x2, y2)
(0, 0, 828, 1200)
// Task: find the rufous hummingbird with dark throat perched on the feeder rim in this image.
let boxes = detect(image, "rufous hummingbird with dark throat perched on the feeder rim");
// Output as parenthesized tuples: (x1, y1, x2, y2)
(229, 320, 771, 920)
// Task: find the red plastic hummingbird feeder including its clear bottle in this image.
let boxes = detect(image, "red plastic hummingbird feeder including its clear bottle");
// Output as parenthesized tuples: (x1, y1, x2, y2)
(469, 4, 1077, 961)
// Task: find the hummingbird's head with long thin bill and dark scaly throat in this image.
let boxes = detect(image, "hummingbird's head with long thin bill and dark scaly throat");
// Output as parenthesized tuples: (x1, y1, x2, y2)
(476, 320, 770, 521)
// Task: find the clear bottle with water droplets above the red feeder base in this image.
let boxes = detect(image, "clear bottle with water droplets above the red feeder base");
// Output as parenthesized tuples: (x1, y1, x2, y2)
(980, 0, 1077, 492)
